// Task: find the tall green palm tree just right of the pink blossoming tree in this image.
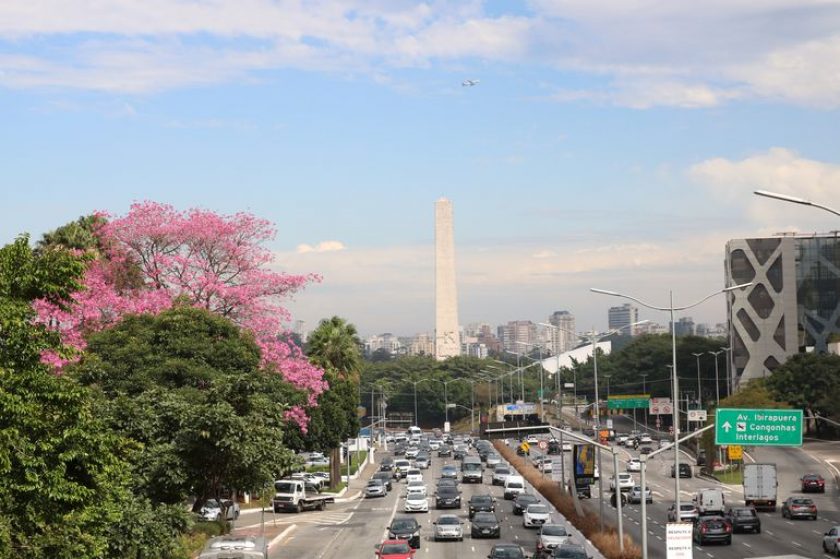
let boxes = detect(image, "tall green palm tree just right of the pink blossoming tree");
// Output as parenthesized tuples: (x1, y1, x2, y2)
(307, 316, 362, 486)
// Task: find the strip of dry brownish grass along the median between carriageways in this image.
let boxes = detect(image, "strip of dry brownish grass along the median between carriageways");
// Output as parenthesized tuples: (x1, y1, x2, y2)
(493, 441, 642, 559)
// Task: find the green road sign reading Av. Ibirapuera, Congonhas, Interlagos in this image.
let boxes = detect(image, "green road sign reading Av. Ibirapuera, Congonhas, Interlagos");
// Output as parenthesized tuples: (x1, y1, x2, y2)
(715, 408, 802, 446)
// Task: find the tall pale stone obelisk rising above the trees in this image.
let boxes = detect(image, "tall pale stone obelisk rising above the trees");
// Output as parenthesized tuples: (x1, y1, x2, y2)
(435, 198, 461, 360)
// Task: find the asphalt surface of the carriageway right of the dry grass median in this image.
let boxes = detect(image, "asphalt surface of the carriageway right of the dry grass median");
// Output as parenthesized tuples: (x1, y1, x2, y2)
(532, 417, 840, 559)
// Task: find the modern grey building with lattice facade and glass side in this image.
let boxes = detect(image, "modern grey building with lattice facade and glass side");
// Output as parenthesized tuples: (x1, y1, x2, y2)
(725, 232, 840, 389)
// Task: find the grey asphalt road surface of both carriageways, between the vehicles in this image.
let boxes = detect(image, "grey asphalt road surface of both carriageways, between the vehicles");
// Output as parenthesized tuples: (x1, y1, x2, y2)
(230, 419, 840, 559)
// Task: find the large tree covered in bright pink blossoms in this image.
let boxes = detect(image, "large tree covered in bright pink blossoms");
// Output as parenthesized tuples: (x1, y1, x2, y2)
(34, 202, 327, 428)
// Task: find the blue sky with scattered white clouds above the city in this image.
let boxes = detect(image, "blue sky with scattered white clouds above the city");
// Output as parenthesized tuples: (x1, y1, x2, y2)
(0, 0, 840, 336)
